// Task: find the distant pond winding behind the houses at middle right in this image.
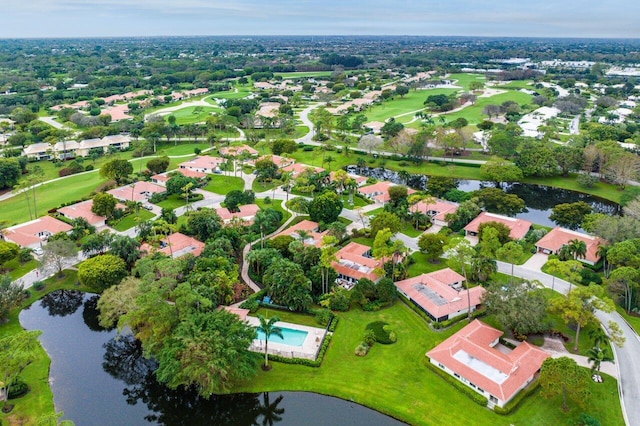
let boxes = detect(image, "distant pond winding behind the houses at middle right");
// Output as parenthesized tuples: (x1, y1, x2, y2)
(348, 166, 620, 227)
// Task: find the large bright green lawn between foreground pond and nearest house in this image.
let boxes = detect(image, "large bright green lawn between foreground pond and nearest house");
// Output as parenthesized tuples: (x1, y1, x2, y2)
(233, 302, 624, 426)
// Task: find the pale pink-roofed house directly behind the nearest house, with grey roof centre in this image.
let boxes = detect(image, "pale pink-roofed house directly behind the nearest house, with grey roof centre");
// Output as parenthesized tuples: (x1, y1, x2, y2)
(395, 268, 485, 322)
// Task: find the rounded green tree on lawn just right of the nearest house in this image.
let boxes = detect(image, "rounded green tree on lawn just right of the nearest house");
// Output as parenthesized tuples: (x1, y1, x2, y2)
(539, 356, 590, 412)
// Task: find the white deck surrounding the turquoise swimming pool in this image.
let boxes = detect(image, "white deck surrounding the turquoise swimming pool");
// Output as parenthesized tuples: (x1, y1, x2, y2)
(247, 316, 326, 360)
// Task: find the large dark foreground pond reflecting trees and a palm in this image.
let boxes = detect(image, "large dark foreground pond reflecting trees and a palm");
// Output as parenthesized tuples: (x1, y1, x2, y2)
(20, 291, 403, 426)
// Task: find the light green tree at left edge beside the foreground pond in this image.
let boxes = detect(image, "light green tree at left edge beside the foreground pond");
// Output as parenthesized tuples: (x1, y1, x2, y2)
(0, 331, 42, 407)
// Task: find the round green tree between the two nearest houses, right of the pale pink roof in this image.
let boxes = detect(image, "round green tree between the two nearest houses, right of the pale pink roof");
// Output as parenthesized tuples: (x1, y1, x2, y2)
(482, 281, 549, 336)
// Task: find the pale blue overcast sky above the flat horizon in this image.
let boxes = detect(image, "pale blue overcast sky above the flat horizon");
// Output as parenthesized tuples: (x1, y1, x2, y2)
(0, 0, 640, 38)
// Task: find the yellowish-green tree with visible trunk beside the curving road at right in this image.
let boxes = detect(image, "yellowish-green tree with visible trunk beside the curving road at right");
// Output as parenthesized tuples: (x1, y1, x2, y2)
(549, 284, 614, 351)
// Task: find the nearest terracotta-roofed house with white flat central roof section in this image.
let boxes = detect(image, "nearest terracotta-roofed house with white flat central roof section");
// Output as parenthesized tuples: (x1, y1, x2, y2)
(427, 320, 550, 408)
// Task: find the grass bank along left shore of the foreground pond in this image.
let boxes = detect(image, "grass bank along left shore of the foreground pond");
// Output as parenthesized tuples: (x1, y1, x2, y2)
(0, 270, 88, 425)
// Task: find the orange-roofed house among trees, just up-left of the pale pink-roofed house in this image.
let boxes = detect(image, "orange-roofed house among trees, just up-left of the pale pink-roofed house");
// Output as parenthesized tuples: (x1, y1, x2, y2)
(331, 242, 383, 284)
